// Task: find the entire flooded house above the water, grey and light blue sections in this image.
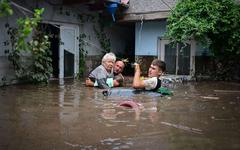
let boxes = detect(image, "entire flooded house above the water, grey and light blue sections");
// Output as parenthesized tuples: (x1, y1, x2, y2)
(0, 0, 213, 84)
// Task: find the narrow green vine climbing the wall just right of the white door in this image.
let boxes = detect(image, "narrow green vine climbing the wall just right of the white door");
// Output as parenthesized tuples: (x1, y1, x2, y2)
(77, 33, 87, 78)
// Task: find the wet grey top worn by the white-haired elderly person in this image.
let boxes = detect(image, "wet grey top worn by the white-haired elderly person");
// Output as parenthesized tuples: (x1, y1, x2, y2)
(89, 65, 114, 89)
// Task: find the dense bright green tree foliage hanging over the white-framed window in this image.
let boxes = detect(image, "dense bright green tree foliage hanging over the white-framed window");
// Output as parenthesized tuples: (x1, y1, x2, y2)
(166, 0, 240, 55)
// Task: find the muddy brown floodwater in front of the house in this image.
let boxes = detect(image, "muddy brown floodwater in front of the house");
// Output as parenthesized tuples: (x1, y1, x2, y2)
(0, 80, 240, 150)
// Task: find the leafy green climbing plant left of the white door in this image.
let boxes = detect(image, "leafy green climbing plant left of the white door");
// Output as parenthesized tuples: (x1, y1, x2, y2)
(6, 9, 52, 83)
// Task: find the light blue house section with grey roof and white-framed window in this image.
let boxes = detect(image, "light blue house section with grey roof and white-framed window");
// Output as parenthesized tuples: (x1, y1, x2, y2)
(119, 0, 215, 79)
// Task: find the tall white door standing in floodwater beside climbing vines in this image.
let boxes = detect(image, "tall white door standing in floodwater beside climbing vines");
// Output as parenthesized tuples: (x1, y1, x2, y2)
(40, 23, 79, 78)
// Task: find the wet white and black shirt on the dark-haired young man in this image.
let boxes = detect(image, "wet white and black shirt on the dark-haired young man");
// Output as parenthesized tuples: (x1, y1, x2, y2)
(143, 77, 161, 91)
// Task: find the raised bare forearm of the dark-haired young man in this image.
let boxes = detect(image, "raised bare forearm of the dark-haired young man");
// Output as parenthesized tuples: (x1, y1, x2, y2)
(132, 64, 145, 89)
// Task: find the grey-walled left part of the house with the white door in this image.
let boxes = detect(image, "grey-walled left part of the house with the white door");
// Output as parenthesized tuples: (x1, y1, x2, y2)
(0, 0, 134, 85)
